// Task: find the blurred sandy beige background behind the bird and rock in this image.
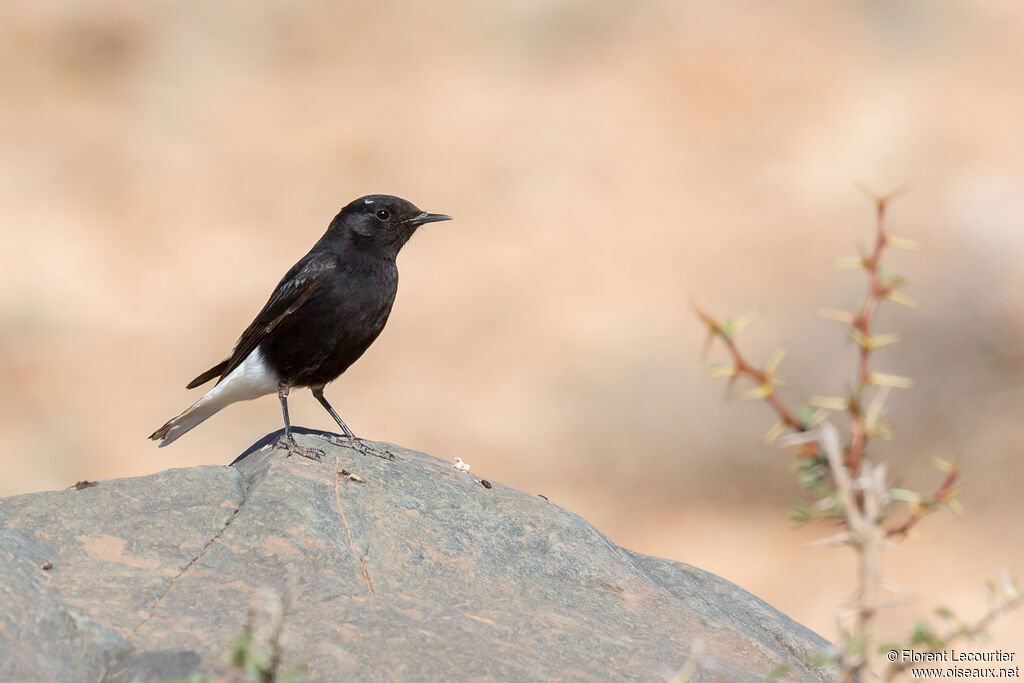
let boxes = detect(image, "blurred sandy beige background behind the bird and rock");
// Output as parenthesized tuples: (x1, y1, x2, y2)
(0, 0, 1024, 656)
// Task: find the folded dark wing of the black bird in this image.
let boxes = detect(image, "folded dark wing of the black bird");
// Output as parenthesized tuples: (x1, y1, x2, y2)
(197, 253, 335, 386)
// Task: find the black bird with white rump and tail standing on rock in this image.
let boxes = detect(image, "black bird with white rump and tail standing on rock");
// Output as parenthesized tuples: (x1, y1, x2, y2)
(150, 195, 452, 459)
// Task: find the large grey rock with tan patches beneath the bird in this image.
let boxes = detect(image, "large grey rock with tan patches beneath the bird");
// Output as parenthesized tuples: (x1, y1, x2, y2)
(0, 434, 828, 682)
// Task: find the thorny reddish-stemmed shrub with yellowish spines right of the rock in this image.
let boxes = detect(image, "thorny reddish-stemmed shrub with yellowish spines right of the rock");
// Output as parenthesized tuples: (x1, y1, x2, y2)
(693, 188, 1021, 682)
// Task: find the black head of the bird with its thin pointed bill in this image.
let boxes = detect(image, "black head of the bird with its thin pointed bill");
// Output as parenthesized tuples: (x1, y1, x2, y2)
(328, 195, 452, 257)
